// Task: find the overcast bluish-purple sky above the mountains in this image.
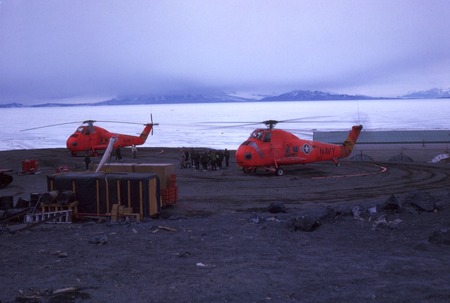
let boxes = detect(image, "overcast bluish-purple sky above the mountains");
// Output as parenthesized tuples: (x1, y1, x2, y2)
(0, 0, 450, 103)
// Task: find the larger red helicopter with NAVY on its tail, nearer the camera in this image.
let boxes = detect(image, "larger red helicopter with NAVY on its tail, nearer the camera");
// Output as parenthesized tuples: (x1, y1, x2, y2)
(236, 120, 363, 176)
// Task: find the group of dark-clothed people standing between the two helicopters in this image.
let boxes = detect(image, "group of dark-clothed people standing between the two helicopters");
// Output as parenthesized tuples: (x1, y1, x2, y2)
(180, 148, 230, 171)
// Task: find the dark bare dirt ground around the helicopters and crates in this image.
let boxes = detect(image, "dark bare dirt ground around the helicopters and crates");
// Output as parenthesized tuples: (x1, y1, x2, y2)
(0, 148, 450, 303)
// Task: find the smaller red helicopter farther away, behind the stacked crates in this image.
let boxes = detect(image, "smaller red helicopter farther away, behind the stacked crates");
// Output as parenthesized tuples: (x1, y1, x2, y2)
(23, 118, 158, 156)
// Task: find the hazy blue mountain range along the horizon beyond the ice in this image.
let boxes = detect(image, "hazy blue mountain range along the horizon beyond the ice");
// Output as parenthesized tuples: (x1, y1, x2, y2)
(0, 88, 450, 108)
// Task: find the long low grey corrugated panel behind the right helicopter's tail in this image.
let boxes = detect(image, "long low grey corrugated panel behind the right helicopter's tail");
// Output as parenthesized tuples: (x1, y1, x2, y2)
(313, 130, 450, 144)
